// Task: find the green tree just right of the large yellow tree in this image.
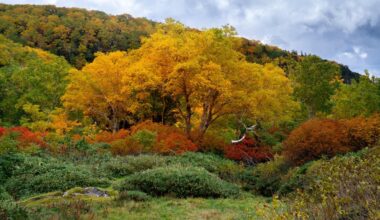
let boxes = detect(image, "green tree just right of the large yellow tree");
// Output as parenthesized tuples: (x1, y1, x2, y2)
(290, 56, 340, 118)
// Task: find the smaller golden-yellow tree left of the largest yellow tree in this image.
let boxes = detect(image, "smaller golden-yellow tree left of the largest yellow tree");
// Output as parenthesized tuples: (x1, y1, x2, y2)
(62, 52, 141, 131)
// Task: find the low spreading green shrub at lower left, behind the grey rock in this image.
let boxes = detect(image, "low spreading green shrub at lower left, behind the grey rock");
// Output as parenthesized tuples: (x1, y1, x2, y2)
(5, 157, 109, 198)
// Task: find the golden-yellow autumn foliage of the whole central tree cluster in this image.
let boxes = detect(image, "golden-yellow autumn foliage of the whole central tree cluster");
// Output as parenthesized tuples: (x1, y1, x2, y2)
(62, 21, 296, 140)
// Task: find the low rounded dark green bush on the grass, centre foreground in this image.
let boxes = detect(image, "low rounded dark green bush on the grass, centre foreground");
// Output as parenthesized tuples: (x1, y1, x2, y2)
(125, 166, 239, 197)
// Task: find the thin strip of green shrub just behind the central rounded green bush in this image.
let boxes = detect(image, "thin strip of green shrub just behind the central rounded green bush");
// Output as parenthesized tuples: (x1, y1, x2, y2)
(168, 152, 244, 182)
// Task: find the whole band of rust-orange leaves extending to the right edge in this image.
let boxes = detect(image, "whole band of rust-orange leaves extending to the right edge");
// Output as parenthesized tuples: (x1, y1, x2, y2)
(283, 115, 380, 165)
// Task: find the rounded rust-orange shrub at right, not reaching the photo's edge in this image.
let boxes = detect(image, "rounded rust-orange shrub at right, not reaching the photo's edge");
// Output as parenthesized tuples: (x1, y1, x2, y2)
(283, 119, 350, 165)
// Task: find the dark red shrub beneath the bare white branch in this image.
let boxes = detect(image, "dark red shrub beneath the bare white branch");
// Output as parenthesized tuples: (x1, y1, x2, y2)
(224, 137, 273, 163)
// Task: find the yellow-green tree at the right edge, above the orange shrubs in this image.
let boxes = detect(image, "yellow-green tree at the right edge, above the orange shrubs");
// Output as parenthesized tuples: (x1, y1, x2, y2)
(332, 73, 380, 118)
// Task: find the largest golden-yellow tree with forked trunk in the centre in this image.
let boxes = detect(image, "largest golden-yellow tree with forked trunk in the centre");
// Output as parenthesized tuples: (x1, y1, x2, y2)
(123, 20, 296, 140)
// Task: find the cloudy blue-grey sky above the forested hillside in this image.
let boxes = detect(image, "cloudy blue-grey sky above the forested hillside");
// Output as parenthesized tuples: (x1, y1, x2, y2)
(0, 0, 380, 77)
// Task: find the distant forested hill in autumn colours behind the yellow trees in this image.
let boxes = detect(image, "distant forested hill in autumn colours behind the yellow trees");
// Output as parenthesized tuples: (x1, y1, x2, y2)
(0, 4, 360, 83)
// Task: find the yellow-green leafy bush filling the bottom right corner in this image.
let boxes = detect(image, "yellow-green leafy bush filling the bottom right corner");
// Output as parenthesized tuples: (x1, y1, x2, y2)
(282, 147, 380, 220)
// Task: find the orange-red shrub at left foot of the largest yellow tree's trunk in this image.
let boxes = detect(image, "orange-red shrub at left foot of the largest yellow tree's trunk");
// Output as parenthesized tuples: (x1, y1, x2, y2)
(131, 121, 198, 154)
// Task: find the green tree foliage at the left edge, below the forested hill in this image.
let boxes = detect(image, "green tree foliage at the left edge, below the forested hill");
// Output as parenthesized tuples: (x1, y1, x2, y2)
(0, 34, 70, 124)
